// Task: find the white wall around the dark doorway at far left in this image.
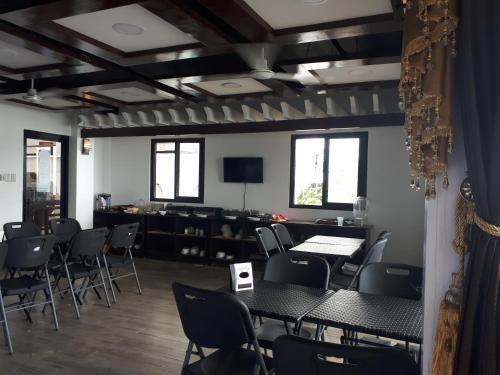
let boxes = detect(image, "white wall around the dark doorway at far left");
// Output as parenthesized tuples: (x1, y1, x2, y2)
(0, 102, 71, 232)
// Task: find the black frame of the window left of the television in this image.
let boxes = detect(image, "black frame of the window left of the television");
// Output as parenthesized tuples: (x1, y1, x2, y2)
(149, 138, 205, 203)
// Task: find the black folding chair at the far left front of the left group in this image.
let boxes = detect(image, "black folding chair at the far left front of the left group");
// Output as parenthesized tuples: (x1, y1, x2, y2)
(0, 235, 59, 353)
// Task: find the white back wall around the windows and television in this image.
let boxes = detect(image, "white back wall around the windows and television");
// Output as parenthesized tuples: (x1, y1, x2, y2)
(94, 127, 424, 265)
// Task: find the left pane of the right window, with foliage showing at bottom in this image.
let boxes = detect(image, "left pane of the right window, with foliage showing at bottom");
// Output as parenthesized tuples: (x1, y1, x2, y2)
(293, 138, 325, 206)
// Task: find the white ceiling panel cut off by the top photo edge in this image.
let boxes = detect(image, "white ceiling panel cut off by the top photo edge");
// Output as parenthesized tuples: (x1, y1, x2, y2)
(244, 0, 392, 30)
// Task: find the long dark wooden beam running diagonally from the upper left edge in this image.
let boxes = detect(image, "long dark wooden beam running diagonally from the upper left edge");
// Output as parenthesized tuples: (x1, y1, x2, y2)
(0, 20, 193, 100)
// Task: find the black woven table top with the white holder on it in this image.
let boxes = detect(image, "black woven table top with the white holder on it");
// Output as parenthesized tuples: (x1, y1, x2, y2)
(231, 280, 333, 323)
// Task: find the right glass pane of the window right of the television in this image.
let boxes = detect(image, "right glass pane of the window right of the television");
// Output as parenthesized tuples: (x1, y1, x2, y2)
(328, 138, 359, 203)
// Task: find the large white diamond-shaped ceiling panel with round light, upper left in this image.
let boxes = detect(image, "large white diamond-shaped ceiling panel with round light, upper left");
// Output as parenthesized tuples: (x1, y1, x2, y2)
(54, 4, 197, 52)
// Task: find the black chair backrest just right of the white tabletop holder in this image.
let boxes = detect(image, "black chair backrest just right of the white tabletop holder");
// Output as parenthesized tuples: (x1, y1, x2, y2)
(262, 252, 330, 289)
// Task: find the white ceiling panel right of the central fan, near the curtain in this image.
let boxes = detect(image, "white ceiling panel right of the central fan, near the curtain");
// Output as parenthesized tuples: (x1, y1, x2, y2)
(314, 63, 401, 85)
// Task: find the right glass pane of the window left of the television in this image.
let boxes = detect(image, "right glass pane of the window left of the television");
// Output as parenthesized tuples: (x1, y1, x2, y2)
(179, 142, 200, 197)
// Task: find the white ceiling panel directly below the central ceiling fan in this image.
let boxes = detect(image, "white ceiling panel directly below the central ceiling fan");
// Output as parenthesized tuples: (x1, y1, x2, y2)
(192, 78, 272, 96)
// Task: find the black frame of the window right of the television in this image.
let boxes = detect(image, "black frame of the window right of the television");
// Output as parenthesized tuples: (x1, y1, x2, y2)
(289, 132, 368, 211)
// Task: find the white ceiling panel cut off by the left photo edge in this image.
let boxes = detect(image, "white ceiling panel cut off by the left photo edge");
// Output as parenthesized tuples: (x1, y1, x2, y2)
(0, 40, 60, 69)
